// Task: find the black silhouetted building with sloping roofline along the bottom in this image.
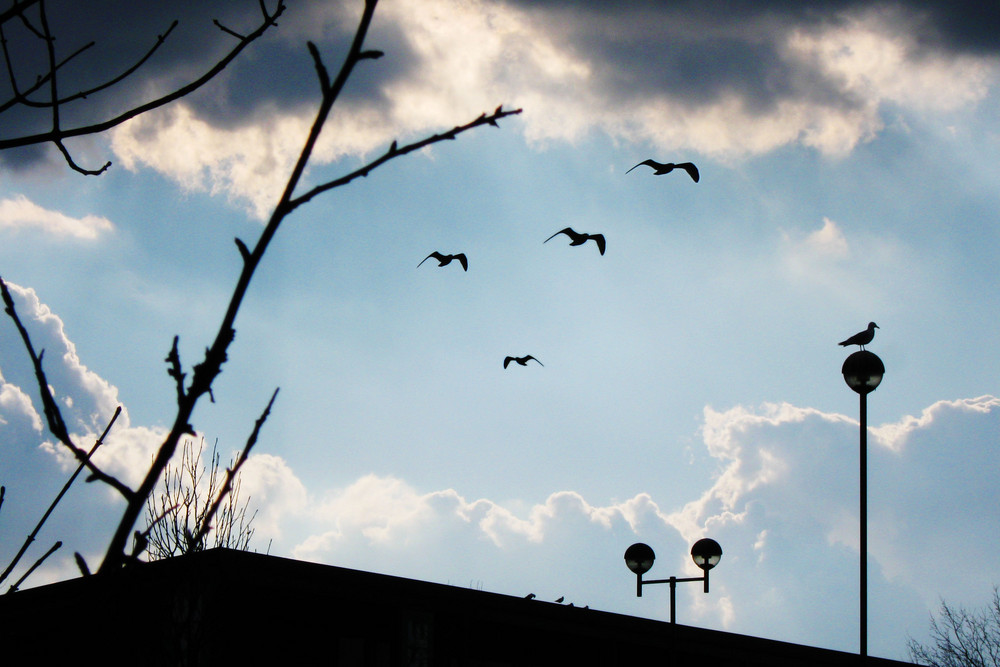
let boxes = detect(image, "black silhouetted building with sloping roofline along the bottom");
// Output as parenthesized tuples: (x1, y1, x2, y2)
(0, 549, 907, 667)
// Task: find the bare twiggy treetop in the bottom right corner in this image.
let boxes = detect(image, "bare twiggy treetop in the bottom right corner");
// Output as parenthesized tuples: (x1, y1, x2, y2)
(907, 586, 1000, 667)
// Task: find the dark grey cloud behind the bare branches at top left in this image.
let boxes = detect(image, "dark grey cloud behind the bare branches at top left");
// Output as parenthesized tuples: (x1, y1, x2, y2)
(0, 0, 413, 154)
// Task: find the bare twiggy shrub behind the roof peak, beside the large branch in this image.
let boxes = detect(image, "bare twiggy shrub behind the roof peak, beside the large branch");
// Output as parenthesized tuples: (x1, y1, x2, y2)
(140, 439, 257, 560)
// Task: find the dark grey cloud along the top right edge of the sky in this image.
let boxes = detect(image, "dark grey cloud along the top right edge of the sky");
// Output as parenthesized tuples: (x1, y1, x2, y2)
(507, 0, 1000, 113)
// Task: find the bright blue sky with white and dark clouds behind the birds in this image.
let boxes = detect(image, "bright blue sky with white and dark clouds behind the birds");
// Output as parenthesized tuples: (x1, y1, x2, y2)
(0, 0, 1000, 659)
